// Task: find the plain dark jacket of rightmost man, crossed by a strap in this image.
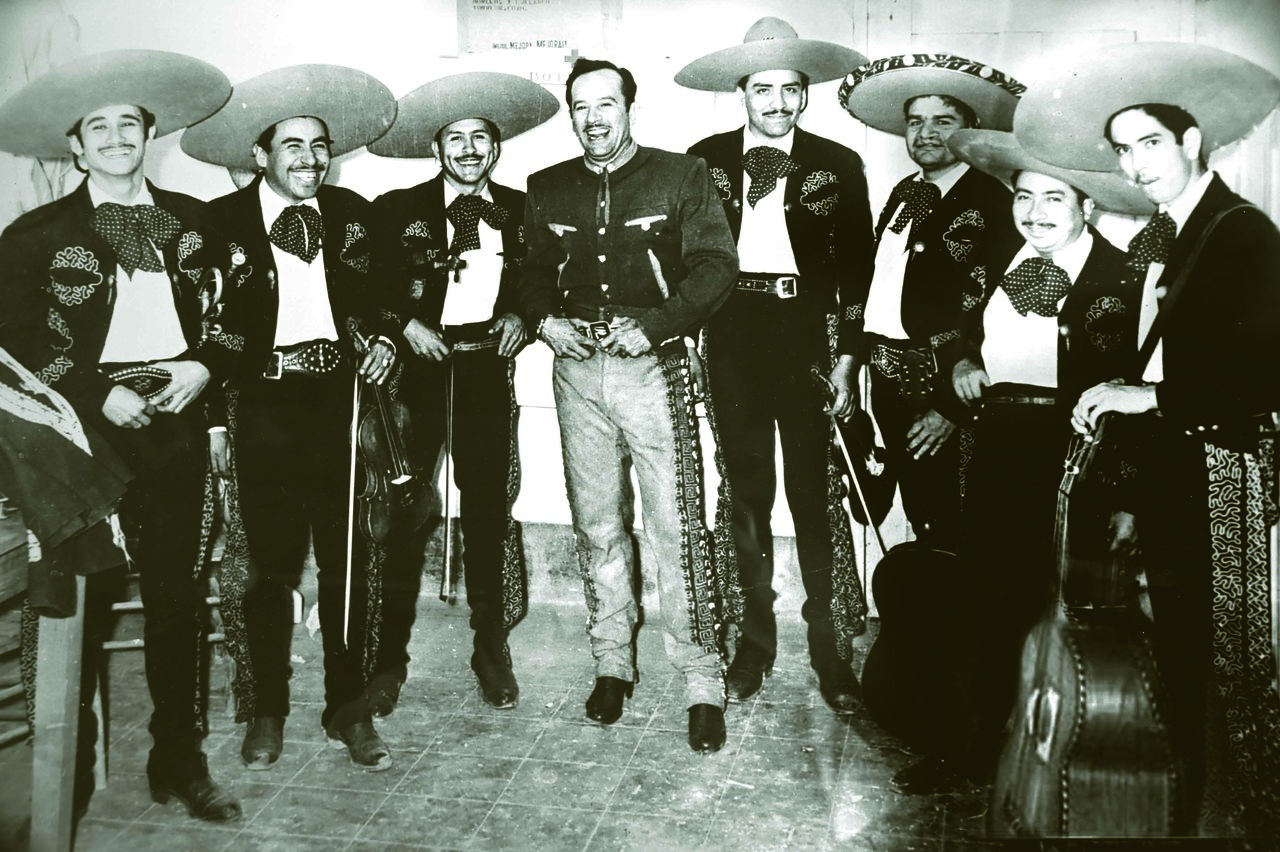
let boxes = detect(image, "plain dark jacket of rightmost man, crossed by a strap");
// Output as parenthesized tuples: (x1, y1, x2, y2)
(1156, 175, 1280, 431)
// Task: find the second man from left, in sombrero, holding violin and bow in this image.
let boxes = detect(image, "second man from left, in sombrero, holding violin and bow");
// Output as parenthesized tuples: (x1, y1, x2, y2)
(182, 65, 396, 770)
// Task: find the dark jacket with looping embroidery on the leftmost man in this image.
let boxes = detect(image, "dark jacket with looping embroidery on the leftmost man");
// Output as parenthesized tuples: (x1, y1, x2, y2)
(0, 178, 237, 417)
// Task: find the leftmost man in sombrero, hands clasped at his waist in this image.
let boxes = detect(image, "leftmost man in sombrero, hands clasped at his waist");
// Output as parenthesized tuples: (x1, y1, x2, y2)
(0, 51, 241, 820)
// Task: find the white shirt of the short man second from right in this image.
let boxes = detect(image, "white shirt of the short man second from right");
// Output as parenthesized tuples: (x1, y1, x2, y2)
(982, 229, 1093, 388)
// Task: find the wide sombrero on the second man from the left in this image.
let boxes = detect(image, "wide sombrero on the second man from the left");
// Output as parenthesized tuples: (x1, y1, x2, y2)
(182, 65, 396, 170)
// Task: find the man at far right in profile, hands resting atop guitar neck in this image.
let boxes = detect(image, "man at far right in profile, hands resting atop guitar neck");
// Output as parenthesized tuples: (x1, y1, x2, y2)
(1018, 43, 1280, 842)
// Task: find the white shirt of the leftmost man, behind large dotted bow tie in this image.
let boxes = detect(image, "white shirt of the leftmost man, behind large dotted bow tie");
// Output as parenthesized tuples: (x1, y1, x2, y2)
(94, 178, 187, 363)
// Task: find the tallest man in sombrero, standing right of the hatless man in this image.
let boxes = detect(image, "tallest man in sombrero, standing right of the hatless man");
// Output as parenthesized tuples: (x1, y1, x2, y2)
(676, 18, 872, 715)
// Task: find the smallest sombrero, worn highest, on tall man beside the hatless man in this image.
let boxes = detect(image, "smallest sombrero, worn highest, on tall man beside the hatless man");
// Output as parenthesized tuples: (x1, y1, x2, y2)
(676, 18, 867, 92)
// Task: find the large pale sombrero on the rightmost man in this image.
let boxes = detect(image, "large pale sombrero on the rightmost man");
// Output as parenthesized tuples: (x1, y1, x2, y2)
(1014, 42, 1280, 171)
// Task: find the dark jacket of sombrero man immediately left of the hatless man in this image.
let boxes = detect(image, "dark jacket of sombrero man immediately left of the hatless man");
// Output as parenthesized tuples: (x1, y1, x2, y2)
(372, 175, 525, 330)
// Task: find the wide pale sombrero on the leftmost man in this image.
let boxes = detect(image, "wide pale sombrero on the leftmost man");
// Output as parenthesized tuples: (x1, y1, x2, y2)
(0, 50, 232, 157)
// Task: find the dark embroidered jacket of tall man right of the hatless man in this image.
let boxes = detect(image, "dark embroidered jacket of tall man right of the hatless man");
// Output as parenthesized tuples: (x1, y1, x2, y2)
(689, 128, 873, 354)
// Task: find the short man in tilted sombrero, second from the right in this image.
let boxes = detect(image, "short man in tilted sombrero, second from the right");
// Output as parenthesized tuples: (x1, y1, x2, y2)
(916, 129, 1151, 784)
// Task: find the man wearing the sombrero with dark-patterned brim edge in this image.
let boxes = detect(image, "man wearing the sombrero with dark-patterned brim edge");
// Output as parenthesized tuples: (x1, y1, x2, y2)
(840, 54, 1025, 550)
